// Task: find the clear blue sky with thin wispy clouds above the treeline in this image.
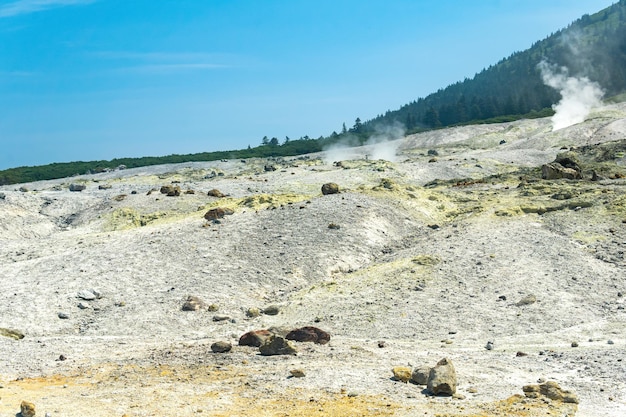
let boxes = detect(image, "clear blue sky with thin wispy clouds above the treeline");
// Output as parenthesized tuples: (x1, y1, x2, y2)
(0, 0, 614, 169)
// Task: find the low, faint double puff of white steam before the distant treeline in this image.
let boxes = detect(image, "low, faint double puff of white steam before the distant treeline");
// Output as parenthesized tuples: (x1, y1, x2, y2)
(324, 123, 406, 164)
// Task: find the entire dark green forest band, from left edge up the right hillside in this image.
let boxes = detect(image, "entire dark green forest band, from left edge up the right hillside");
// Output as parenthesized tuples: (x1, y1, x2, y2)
(0, 0, 626, 185)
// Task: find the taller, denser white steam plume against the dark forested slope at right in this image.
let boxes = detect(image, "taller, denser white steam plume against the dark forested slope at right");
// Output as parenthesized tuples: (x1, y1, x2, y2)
(539, 61, 604, 130)
